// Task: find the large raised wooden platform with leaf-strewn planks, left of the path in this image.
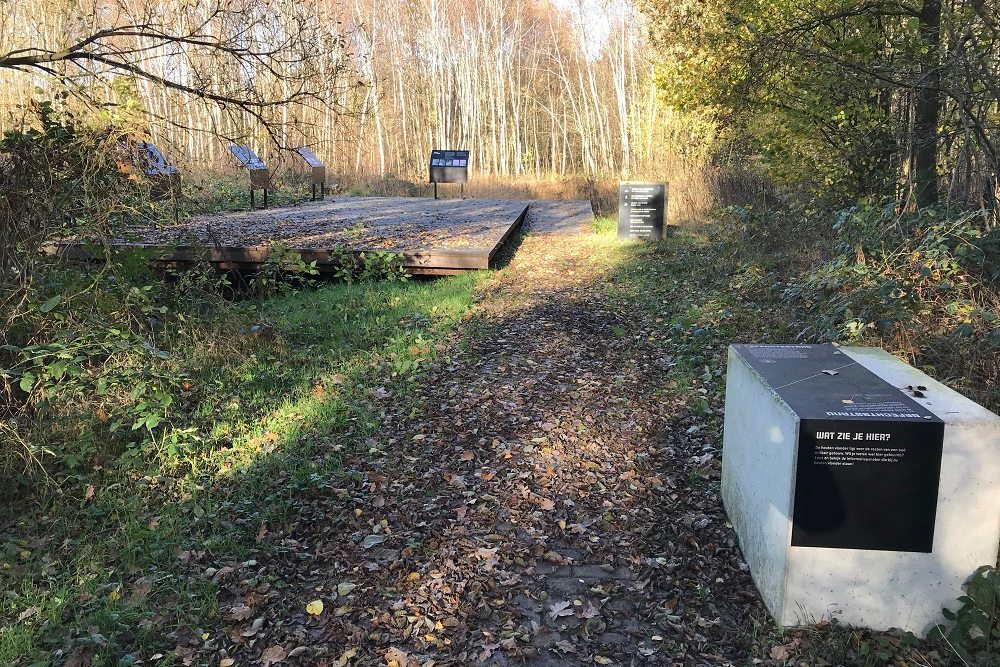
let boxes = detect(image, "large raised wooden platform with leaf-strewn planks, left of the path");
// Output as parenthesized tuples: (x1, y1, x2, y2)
(60, 197, 528, 275)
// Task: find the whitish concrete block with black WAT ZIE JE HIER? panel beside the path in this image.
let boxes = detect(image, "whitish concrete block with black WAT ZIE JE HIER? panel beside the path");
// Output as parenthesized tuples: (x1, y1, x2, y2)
(722, 345, 1000, 635)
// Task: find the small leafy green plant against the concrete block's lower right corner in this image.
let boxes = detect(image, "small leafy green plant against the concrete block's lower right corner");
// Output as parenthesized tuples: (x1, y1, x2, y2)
(930, 565, 1000, 667)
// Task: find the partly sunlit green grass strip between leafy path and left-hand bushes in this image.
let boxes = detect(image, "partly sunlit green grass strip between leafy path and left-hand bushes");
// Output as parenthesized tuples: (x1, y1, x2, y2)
(0, 274, 485, 666)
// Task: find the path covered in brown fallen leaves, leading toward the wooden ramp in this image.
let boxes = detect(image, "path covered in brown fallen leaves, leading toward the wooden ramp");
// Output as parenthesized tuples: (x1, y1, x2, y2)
(220, 232, 760, 667)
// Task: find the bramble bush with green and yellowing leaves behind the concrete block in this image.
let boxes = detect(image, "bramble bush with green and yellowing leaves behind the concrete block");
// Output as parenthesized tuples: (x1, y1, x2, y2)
(782, 201, 1000, 409)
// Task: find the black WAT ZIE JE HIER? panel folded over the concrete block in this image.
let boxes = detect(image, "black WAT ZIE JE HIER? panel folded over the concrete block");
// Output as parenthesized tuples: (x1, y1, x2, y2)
(734, 345, 944, 553)
